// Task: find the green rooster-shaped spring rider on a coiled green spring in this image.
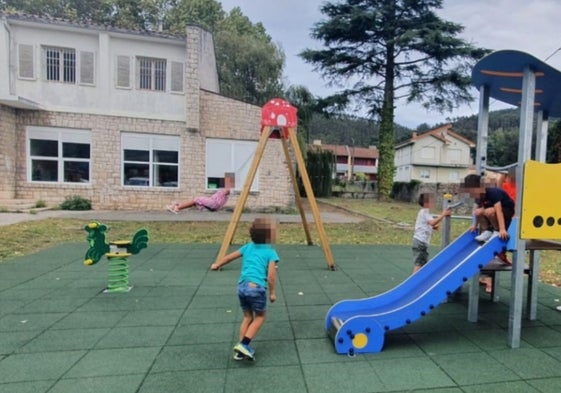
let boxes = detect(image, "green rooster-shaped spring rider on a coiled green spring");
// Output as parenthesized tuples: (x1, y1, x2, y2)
(84, 221, 148, 292)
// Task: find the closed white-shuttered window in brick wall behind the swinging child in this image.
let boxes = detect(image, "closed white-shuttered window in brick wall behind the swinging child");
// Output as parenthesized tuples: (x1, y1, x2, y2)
(206, 138, 259, 192)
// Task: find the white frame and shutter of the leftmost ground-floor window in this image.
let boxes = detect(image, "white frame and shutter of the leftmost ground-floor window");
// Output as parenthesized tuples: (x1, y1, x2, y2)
(26, 126, 92, 185)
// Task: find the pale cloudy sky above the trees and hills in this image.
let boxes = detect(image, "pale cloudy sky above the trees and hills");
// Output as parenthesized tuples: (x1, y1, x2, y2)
(218, 0, 561, 129)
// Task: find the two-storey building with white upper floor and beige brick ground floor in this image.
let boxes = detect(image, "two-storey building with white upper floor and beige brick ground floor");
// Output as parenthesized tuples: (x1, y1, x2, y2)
(0, 13, 294, 209)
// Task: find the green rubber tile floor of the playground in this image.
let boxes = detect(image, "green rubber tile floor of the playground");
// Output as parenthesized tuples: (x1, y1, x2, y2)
(0, 239, 561, 393)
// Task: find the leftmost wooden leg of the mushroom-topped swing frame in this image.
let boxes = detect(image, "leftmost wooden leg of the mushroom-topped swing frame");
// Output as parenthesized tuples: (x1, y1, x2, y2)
(215, 127, 271, 262)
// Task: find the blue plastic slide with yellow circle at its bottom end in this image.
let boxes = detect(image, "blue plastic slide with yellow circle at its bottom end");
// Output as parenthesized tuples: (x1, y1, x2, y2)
(325, 230, 506, 355)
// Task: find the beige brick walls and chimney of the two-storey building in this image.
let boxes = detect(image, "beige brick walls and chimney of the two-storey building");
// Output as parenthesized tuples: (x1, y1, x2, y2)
(0, 22, 294, 210)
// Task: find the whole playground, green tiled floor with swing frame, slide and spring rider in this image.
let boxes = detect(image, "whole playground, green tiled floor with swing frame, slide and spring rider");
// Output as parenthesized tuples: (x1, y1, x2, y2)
(0, 51, 561, 392)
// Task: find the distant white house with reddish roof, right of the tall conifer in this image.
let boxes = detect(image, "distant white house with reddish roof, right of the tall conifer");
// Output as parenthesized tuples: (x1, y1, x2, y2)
(394, 124, 475, 183)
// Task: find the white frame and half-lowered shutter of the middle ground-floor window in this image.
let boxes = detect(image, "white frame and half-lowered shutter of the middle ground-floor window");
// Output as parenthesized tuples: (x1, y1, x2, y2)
(121, 132, 181, 190)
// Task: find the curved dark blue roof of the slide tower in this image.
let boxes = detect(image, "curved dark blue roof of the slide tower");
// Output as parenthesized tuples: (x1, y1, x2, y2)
(471, 50, 561, 117)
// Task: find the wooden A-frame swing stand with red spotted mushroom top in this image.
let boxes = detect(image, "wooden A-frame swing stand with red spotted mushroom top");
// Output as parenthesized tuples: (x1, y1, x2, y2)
(216, 98, 335, 270)
